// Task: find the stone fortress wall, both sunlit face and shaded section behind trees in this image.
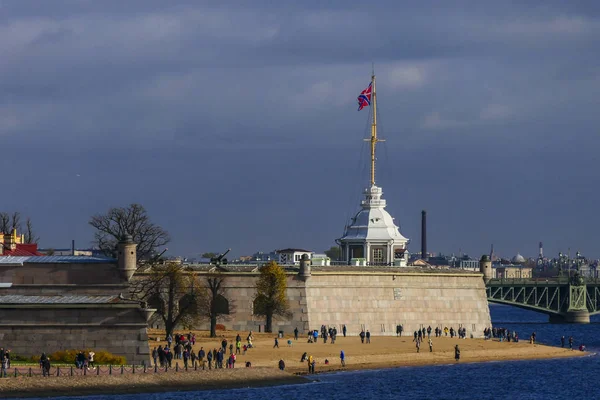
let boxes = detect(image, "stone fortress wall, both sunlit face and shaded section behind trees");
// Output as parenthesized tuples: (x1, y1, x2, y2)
(171, 267, 491, 338)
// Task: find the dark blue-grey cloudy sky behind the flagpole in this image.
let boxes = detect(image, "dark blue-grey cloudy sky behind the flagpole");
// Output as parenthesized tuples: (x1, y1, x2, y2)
(0, 0, 600, 258)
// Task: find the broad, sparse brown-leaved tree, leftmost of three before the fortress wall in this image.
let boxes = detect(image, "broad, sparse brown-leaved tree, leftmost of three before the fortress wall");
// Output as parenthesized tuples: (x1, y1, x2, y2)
(130, 262, 205, 336)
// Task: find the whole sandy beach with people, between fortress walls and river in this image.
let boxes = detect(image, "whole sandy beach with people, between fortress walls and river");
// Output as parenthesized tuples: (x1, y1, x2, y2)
(0, 331, 587, 398)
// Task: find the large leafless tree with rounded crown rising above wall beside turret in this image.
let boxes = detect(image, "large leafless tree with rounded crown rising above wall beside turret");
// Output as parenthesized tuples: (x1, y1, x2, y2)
(89, 204, 171, 260)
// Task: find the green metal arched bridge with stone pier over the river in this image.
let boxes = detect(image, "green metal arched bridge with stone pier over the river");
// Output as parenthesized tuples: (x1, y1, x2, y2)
(486, 274, 600, 323)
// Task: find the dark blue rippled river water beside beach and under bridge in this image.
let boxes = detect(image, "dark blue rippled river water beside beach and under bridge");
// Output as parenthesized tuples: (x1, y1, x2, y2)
(16, 305, 600, 400)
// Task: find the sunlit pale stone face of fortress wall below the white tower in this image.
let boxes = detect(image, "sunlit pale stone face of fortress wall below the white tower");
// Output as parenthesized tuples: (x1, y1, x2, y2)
(306, 272, 491, 337)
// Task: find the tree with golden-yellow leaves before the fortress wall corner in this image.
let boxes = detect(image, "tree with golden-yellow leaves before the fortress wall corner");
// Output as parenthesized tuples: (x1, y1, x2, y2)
(254, 261, 290, 332)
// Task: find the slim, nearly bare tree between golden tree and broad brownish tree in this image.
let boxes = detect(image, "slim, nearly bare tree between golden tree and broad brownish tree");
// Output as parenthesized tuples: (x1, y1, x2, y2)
(201, 272, 234, 337)
